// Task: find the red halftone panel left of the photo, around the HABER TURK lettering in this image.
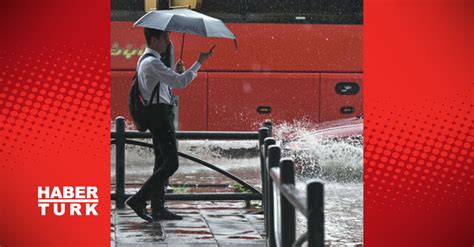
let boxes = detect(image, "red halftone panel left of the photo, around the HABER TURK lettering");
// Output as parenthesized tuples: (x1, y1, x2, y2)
(0, 0, 110, 247)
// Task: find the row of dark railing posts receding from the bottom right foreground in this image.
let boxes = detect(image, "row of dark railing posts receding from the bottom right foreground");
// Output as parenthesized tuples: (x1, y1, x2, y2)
(259, 126, 324, 247)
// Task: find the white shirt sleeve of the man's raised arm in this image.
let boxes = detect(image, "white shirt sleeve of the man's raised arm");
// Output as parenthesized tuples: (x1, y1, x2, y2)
(142, 59, 201, 88)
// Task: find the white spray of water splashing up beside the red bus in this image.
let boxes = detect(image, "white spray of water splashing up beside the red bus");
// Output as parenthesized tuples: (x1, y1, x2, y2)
(274, 122, 363, 182)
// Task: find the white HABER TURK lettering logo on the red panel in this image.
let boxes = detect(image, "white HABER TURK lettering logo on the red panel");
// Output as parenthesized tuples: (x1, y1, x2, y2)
(38, 186, 99, 216)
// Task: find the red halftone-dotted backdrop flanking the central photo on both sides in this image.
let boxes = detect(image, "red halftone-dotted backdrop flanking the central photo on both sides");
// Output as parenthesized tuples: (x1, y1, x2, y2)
(0, 0, 474, 246)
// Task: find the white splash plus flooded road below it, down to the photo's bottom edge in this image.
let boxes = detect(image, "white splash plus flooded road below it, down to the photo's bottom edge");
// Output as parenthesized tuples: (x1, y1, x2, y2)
(273, 122, 363, 246)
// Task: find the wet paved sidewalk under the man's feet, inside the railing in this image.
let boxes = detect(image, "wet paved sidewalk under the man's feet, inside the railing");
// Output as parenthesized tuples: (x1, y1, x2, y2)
(111, 201, 265, 246)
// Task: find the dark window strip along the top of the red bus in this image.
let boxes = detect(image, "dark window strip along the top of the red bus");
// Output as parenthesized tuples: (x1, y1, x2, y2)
(111, 0, 363, 24)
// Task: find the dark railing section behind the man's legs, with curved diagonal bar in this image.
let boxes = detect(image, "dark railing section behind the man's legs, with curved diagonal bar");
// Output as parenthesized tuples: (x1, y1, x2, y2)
(111, 117, 262, 208)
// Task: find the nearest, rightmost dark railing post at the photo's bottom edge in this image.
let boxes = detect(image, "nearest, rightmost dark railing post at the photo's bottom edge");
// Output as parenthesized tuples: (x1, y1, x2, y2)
(306, 182, 324, 247)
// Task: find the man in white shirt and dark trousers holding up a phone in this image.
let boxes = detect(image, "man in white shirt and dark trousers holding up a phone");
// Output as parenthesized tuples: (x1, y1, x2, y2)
(126, 28, 212, 222)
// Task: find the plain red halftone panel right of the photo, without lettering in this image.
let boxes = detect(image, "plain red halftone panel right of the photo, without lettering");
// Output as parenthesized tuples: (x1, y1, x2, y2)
(364, 0, 474, 247)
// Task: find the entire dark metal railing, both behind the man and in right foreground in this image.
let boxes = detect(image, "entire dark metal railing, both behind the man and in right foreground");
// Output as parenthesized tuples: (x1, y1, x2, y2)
(111, 117, 324, 247)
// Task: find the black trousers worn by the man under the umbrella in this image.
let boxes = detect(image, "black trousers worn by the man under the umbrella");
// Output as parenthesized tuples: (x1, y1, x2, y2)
(136, 104, 179, 211)
